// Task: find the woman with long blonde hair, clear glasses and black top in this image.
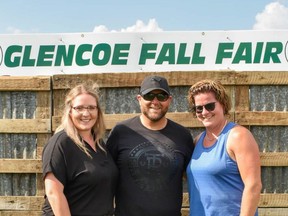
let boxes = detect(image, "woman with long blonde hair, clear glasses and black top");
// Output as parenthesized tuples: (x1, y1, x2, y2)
(42, 84, 118, 216)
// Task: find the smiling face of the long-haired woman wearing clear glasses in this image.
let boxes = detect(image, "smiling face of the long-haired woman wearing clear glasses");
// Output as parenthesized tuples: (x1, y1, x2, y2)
(70, 94, 98, 135)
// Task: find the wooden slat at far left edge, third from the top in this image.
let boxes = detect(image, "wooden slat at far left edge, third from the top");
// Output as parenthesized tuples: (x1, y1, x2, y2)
(0, 159, 42, 173)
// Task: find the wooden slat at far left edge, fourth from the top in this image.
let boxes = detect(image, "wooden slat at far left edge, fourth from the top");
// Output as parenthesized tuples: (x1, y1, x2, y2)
(0, 196, 44, 211)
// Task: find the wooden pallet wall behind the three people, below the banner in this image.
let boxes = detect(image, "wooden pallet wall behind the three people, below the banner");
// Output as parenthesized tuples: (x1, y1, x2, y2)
(0, 71, 288, 216)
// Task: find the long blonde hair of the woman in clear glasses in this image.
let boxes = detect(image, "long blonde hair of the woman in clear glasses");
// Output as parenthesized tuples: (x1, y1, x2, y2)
(55, 81, 106, 157)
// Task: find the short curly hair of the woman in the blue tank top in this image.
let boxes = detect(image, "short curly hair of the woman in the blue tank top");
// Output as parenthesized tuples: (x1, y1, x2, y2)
(188, 79, 231, 115)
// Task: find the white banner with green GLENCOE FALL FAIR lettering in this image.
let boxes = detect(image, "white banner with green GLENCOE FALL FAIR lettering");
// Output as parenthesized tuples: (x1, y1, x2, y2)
(0, 30, 288, 76)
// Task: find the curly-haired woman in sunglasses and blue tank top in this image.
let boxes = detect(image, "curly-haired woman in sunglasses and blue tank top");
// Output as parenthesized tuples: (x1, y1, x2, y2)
(187, 80, 262, 216)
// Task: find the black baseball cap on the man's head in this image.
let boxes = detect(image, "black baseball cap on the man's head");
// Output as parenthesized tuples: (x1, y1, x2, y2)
(140, 75, 170, 95)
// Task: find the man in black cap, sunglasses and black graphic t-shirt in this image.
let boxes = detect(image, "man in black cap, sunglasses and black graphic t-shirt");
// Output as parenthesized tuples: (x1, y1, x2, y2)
(107, 76, 193, 216)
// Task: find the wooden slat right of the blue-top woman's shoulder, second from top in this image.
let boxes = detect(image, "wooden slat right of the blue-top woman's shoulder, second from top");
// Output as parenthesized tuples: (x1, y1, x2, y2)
(235, 111, 288, 126)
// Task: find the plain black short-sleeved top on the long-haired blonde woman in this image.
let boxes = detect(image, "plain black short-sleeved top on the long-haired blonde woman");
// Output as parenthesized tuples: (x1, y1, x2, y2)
(42, 131, 118, 216)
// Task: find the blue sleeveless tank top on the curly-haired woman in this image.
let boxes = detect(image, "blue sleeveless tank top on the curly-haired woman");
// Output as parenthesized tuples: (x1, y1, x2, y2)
(187, 122, 258, 216)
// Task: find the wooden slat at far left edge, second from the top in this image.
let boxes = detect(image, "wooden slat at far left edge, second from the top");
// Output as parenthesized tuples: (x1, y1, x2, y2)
(0, 119, 51, 133)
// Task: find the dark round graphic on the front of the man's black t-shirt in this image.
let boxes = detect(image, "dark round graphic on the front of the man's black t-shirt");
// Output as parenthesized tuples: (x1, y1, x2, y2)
(129, 142, 177, 192)
